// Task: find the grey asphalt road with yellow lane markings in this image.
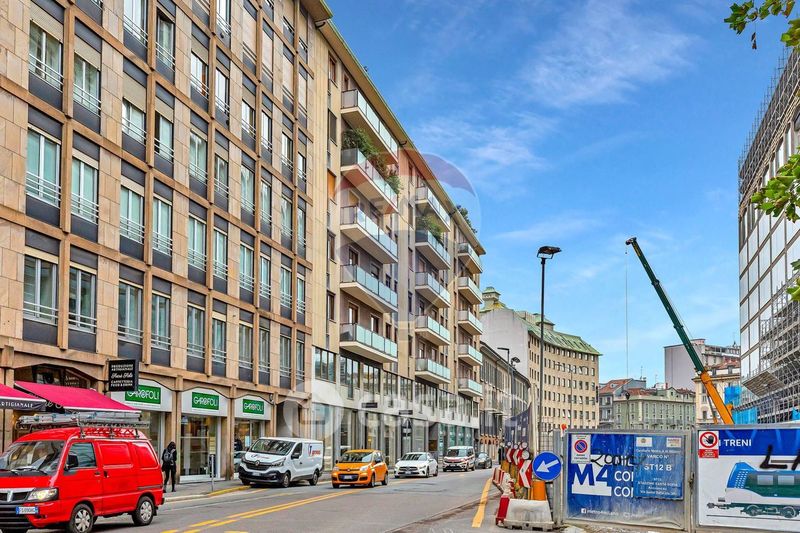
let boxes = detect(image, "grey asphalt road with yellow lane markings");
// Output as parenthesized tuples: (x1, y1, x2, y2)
(69, 470, 497, 533)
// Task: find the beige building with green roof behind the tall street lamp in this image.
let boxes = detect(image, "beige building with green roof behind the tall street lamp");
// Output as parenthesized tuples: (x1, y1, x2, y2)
(481, 287, 600, 444)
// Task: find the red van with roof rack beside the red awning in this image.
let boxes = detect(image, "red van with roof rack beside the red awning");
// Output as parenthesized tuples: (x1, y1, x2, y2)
(0, 427, 164, 533)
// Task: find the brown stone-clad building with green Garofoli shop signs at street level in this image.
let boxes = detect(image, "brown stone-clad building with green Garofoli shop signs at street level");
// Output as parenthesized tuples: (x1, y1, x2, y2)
(0, 0, 330, 481)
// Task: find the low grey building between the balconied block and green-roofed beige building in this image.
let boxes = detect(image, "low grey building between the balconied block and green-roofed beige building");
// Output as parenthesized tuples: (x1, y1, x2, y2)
(478, 342, 535, 462)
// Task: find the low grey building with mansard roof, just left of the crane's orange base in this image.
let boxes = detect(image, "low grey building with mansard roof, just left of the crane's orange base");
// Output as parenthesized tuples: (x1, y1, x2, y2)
(613, 384, 695, 429)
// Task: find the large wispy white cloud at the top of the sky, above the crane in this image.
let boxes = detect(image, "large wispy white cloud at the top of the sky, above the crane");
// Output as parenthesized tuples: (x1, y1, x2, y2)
(521, 0, 695, 108)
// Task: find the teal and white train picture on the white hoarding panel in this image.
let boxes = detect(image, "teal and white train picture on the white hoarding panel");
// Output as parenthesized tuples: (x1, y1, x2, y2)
(708, 462, 800, 518)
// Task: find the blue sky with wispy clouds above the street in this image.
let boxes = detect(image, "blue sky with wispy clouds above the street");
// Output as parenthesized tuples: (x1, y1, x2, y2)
(328, 0, 785, 384)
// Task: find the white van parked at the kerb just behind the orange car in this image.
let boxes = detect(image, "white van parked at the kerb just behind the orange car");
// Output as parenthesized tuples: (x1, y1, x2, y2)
(239, 437, 322, 487)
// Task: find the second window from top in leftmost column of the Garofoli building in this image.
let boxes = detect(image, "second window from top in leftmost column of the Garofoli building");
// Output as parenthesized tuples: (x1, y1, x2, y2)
(25, 130, 61, 207)
